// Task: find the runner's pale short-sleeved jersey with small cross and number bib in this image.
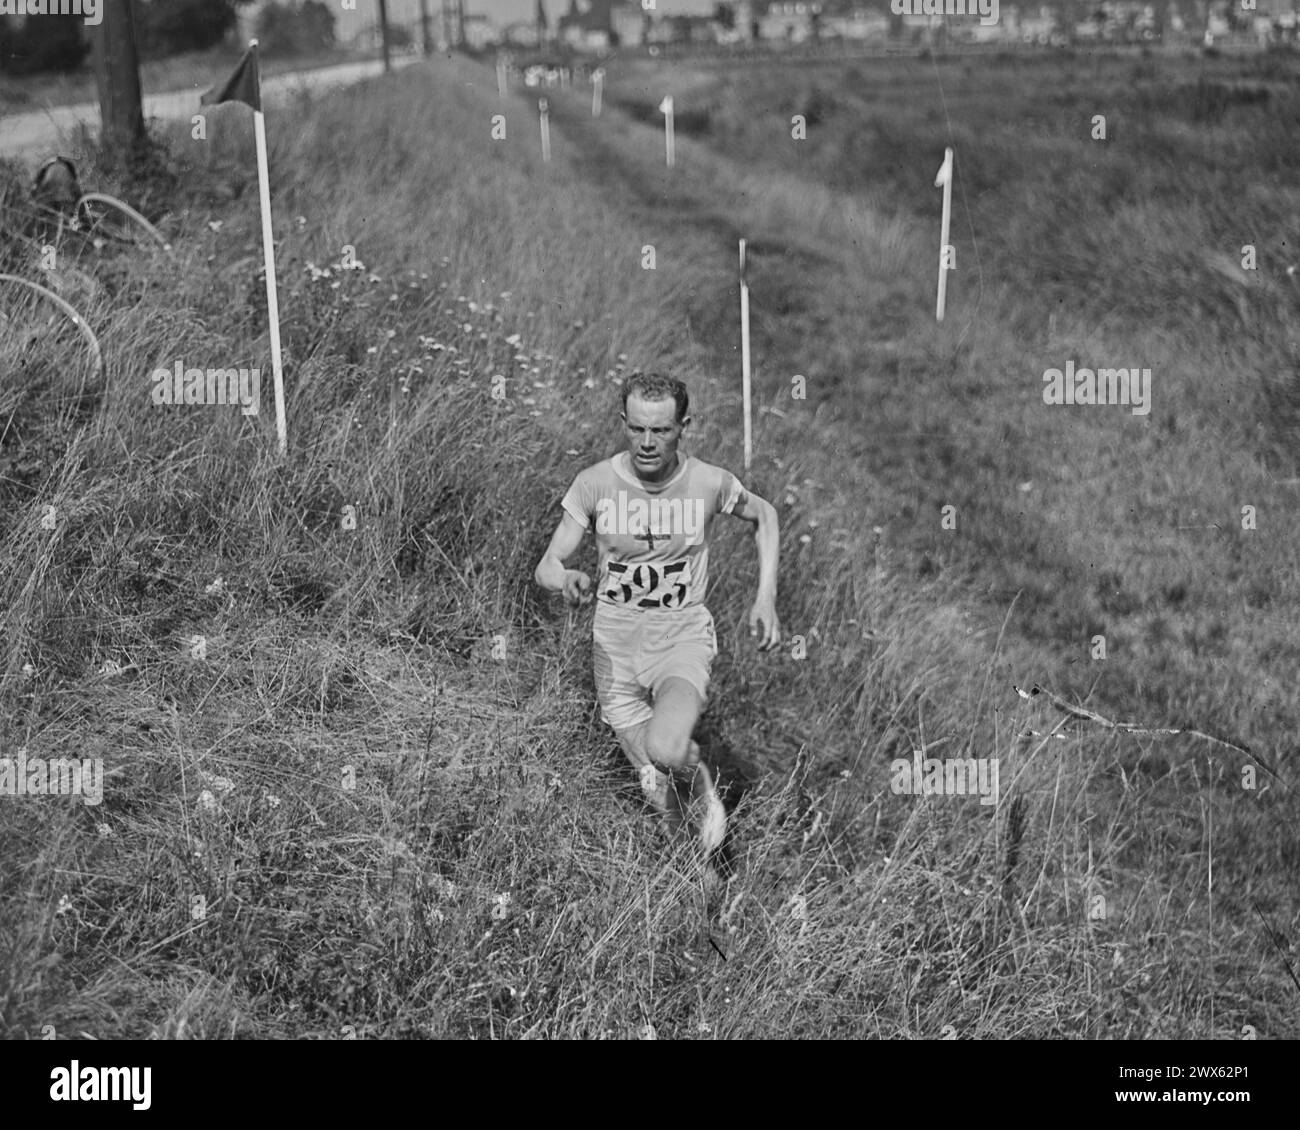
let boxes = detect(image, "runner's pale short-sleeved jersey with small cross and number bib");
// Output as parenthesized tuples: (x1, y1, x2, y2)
(560, 451, 745, 610)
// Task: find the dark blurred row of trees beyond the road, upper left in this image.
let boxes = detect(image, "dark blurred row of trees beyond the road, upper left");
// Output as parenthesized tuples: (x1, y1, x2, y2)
(0, 0, 334, 77)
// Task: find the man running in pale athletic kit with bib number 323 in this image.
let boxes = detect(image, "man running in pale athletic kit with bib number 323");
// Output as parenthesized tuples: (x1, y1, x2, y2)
(533, 373, 780, 853)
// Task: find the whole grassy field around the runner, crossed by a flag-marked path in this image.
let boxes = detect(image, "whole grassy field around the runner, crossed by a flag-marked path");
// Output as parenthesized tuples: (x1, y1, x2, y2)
(0, 46, 1300, 1039)
